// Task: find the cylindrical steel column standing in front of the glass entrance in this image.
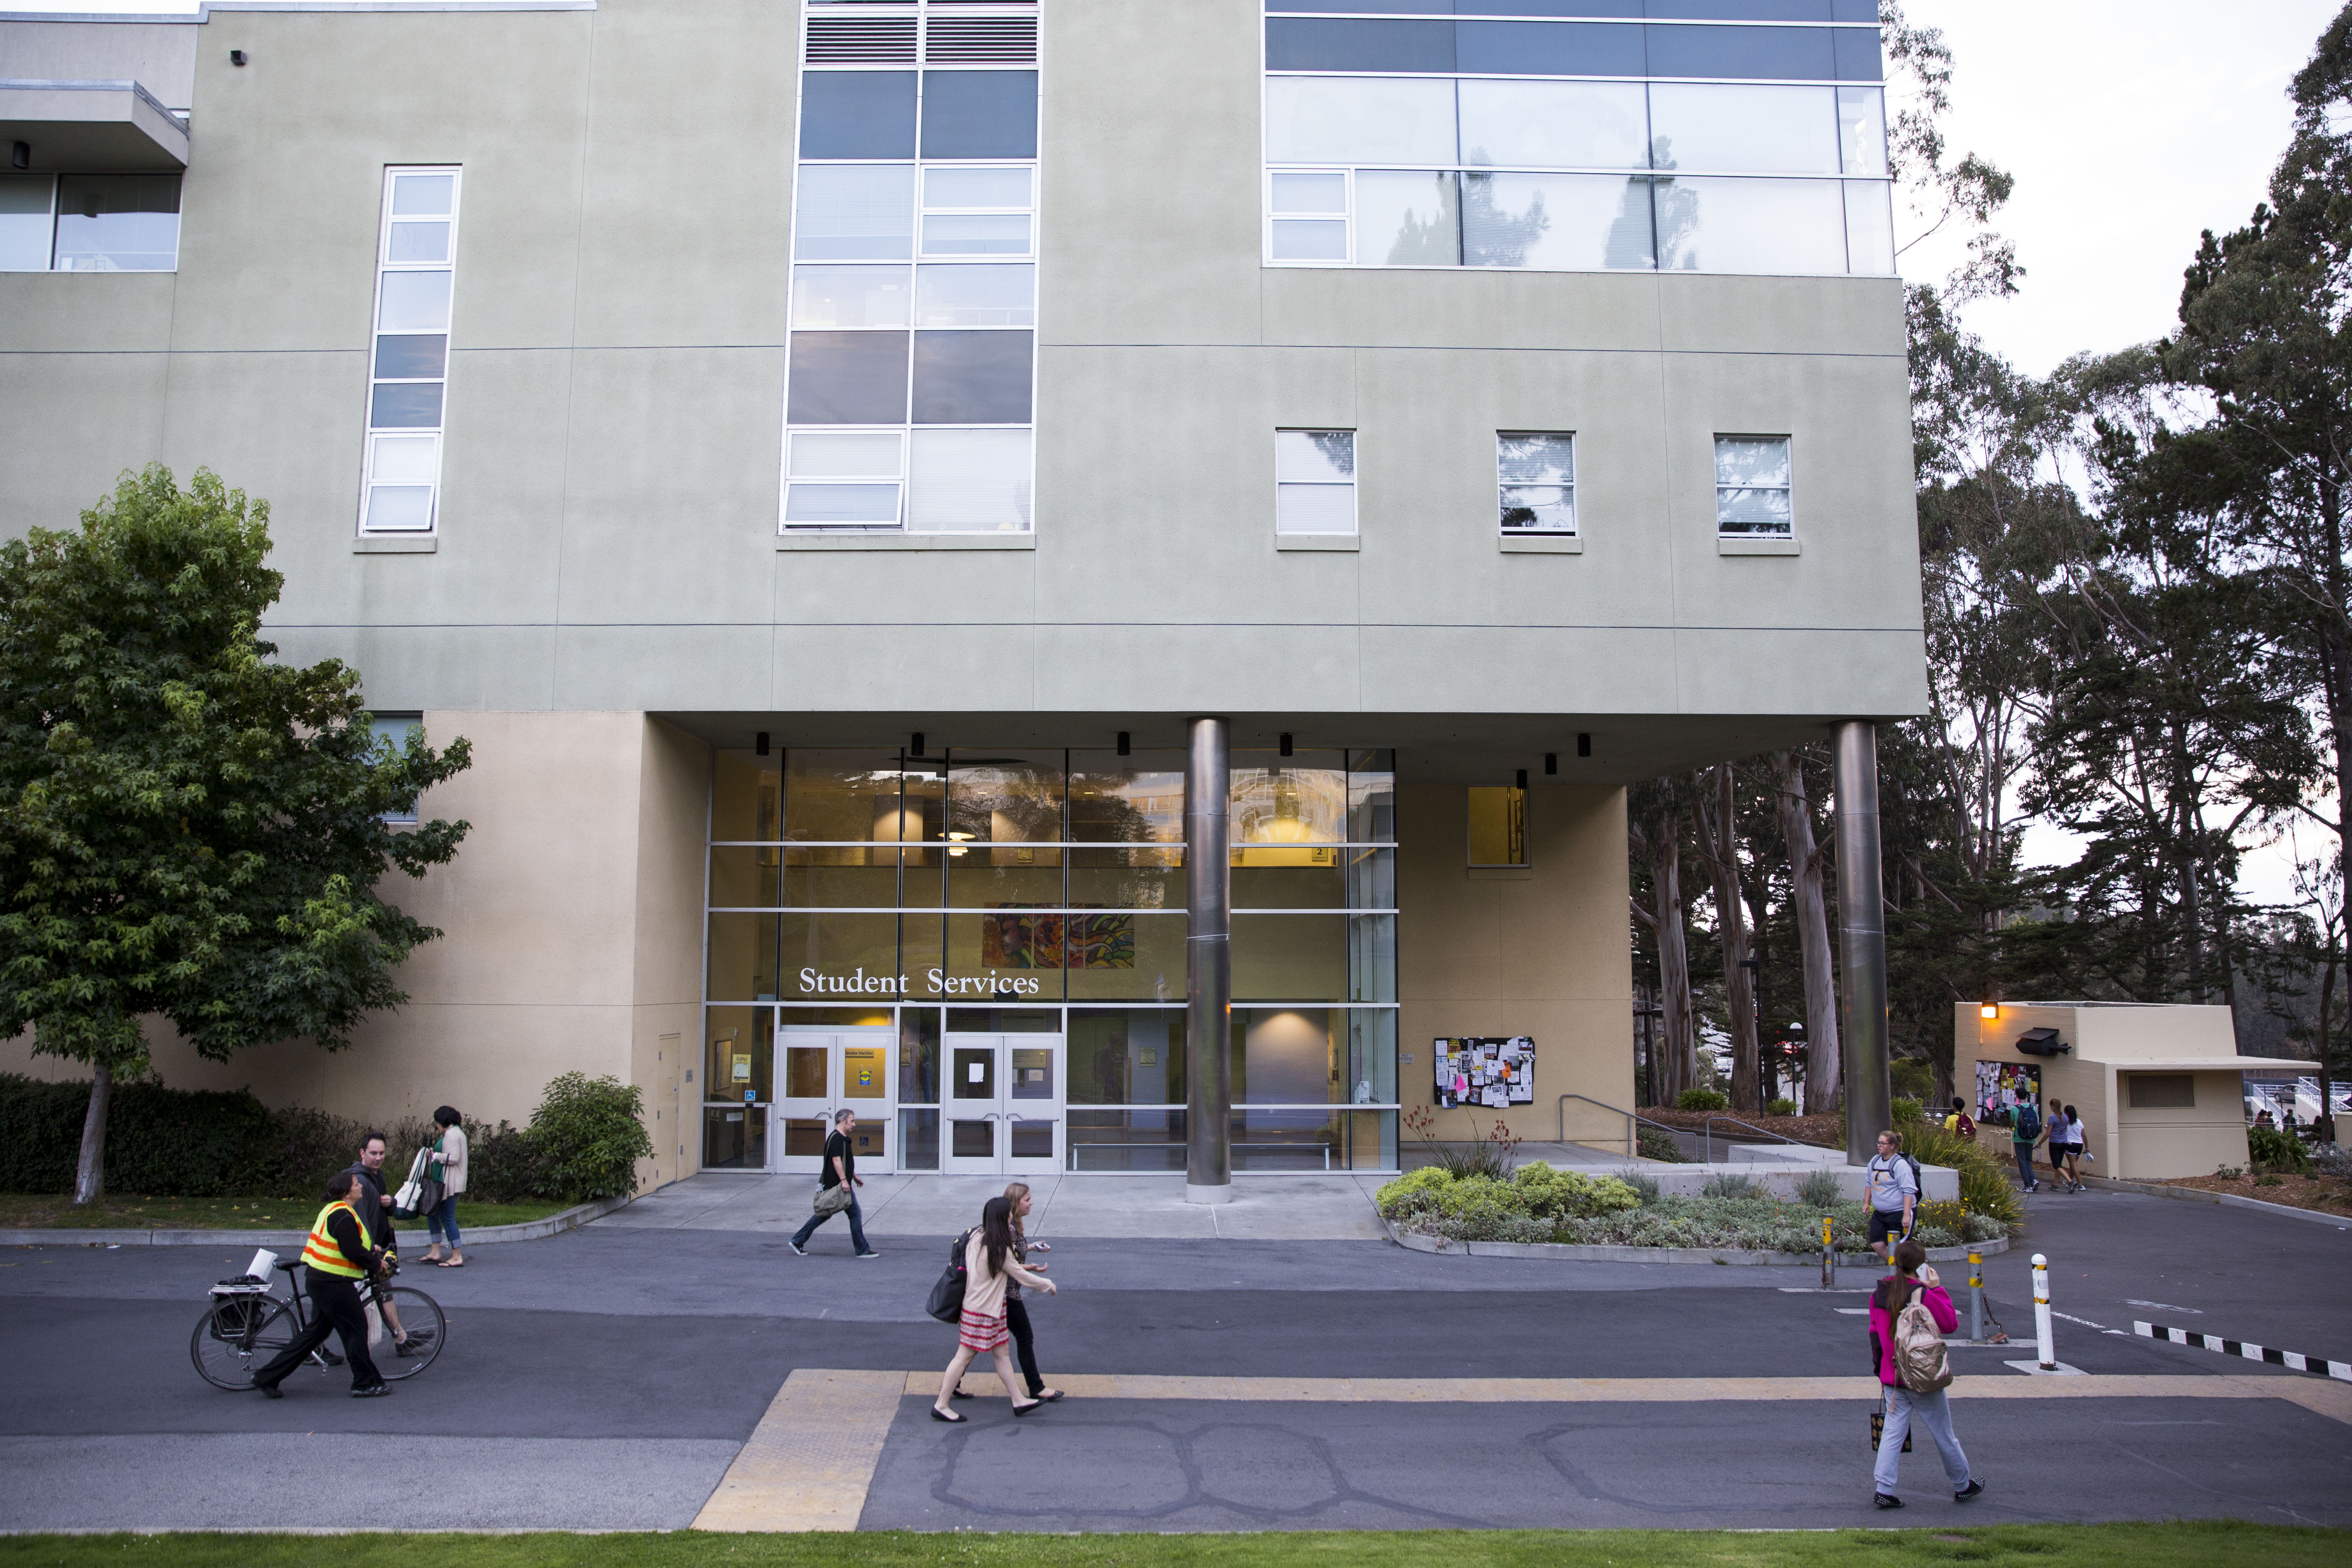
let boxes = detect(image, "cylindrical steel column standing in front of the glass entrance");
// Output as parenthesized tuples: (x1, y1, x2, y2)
(1183, 719, 1232, 1204)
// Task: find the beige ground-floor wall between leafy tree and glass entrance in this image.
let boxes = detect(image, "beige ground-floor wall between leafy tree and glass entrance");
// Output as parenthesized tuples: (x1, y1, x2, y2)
(0, 712, 708, 1185)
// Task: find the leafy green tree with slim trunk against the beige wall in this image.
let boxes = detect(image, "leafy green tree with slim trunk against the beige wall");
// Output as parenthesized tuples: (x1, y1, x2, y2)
(0, 466, 468, 1204)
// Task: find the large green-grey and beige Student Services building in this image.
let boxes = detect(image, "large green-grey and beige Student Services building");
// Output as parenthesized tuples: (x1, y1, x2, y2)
(0, 0, 1924, 1196)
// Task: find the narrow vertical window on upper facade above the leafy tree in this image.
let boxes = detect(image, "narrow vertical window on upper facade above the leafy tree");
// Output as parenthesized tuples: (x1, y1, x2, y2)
(360, 167, 459, 533)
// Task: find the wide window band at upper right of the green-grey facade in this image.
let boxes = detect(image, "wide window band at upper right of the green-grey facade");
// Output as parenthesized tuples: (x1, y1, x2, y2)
(1265, 0, 1896, 275)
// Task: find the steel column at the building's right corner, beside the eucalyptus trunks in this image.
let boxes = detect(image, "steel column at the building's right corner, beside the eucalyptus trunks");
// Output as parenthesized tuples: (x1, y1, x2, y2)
(1837, 719, 1893, 1166)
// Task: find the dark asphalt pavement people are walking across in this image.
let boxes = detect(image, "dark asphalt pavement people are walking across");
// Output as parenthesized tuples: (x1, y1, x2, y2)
(0, 1175, 2352, 1530)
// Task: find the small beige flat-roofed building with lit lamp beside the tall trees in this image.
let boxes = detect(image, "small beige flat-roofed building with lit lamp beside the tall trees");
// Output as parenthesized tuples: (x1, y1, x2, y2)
(1952, 1002, 2303, 1180)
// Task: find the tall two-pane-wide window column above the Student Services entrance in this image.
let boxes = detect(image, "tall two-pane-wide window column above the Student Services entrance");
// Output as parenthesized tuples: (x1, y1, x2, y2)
(781, 0, 1037, 533)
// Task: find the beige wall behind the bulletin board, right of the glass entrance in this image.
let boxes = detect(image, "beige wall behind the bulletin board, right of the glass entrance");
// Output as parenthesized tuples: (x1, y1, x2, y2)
(1397, 783, 1632, 1147)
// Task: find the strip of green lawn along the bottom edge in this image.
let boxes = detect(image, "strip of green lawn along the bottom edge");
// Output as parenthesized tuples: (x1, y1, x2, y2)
(0, 1504, 2352, 1568)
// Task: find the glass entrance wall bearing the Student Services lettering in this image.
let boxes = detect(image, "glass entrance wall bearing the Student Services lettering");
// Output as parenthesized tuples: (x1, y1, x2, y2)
(706, 747, 1397, 1171)
